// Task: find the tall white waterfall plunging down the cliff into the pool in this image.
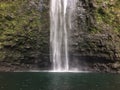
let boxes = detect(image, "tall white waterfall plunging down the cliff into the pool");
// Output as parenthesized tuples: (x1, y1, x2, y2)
(50, 0, 76, 71)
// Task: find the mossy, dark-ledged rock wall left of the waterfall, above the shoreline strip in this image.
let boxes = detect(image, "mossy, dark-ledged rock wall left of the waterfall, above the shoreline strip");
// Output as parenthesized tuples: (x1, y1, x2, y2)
(0, 0, 50, 68)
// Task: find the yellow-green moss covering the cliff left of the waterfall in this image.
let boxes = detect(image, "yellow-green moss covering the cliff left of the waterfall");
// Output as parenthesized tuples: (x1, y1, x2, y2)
(0, 0, 49, 61)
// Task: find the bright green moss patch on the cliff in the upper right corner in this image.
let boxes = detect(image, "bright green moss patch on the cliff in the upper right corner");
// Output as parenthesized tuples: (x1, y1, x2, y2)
(90, 0, 120, 33)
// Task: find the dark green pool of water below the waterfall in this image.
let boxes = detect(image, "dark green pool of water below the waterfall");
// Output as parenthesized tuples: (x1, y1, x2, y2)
(0, 72, 120, 90)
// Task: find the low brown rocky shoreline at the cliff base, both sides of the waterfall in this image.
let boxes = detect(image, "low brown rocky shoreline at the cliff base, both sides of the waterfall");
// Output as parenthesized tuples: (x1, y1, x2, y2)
(0, 57, 120, 73)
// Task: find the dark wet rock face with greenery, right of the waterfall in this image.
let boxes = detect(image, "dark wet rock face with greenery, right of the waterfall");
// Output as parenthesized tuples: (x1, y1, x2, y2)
(71, 0, 120, 72)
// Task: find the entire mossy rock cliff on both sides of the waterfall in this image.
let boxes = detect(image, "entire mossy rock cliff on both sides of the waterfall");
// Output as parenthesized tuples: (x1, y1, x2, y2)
(0, 0, 120, 72)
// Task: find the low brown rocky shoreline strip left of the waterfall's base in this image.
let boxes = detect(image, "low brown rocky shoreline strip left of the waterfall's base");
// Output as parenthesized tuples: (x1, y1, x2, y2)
(0, 62, 51, 72)
